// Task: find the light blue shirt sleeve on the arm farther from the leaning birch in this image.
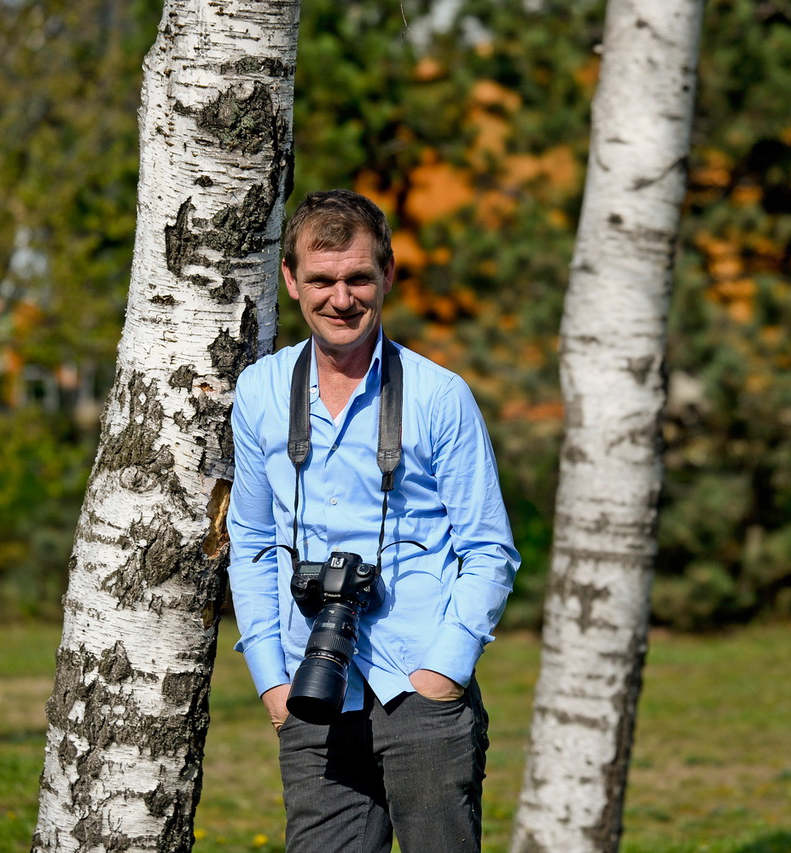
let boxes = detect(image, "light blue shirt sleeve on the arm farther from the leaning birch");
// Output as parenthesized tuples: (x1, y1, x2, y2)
(421, 376, 520, 686)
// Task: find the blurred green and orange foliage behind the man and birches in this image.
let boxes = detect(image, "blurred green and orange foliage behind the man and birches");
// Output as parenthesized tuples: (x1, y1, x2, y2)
(0, 0, 791, 630)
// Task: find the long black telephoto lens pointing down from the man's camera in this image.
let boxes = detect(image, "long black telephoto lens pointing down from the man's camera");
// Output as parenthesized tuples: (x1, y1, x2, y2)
(286, 601, 360, 725)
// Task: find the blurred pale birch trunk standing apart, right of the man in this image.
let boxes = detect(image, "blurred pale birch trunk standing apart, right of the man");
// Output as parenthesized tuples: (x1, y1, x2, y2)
(511, 0, 703, 853)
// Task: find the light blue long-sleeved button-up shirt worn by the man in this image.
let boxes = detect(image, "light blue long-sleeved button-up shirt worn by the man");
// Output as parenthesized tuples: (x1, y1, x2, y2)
(228, 332, 519, 711)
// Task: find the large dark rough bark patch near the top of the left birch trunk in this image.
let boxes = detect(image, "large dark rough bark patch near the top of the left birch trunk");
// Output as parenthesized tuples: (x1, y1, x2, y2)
(192, 81, 277, 154)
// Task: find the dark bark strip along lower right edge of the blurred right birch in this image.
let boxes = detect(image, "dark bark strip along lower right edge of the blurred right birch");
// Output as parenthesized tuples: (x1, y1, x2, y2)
(585, 628, 647, 851)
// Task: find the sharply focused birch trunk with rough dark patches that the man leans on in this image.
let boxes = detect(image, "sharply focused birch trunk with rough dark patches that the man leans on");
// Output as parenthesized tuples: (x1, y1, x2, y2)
(33, 0, 299, 853)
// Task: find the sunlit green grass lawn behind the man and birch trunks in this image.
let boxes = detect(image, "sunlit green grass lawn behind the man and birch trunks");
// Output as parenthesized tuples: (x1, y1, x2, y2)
(0, 622, 791, 853)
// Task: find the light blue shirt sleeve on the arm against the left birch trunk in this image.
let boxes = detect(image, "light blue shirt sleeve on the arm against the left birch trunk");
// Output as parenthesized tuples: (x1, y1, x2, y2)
(228, 372, 289, 696)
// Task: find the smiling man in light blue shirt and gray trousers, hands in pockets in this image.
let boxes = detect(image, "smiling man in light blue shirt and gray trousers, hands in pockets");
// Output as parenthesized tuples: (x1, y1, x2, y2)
(228, 190, 519, 853)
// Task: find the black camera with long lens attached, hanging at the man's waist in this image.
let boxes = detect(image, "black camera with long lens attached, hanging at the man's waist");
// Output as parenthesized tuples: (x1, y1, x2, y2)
(286, 551, 385, 725)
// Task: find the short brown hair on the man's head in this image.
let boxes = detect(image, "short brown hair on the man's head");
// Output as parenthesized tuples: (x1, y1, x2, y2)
(283, 190, 393, 273)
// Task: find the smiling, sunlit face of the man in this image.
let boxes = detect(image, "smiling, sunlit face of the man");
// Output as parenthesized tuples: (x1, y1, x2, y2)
(283, 230, 394, 355)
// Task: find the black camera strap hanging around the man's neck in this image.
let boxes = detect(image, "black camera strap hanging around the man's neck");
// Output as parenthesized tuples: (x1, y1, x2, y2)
(288, 334, 406, 569)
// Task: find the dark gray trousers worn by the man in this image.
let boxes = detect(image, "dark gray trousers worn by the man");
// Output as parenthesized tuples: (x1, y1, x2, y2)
(280, 678, 489, 853)
